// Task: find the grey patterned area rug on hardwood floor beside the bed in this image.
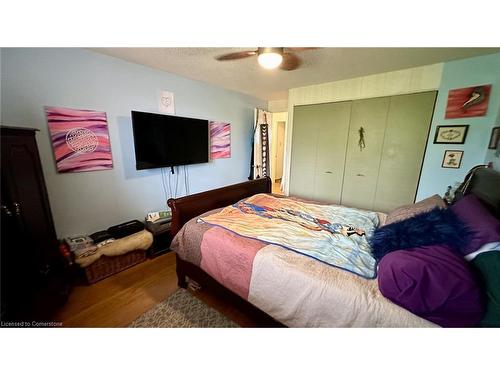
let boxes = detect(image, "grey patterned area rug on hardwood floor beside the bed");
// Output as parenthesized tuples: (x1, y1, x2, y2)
(129, 289, 239, 328)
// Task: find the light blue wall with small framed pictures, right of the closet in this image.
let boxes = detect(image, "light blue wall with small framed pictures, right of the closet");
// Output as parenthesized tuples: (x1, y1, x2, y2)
(417, 53, 500, 201)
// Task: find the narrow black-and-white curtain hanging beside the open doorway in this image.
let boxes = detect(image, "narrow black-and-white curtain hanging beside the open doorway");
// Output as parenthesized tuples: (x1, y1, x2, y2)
(248, 108, 273, 180)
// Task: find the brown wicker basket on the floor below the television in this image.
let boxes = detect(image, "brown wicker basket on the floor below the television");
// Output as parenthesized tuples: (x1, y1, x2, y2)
(85, 250, 146, 284)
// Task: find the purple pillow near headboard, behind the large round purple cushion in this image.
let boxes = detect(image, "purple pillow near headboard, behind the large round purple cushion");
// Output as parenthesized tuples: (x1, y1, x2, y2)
(450, 194, 500, 255)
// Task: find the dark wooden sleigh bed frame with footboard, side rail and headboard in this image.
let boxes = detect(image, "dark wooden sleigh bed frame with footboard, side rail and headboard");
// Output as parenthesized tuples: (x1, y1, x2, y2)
(167, 169, 500, 327)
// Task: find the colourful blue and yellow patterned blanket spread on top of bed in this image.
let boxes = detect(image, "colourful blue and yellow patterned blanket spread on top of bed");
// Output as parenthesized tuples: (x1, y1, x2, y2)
(200, 194, 379, 279)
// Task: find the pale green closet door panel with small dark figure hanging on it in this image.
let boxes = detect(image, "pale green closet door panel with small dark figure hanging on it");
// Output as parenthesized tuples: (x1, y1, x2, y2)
(342, 97, 391, 210)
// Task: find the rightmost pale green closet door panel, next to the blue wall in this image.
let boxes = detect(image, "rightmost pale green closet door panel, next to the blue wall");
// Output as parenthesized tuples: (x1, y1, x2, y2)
(373, 92, 436, 212)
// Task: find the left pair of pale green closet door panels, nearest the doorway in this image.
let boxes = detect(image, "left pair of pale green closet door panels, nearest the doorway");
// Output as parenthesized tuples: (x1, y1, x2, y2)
(290, 102, 351, 203)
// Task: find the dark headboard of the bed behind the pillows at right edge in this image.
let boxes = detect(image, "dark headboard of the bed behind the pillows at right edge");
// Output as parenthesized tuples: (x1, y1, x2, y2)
(465, 168, 500, 219)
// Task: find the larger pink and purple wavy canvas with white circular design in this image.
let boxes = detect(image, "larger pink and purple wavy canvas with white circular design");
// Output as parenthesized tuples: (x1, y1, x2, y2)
(45, 107, 113, 173)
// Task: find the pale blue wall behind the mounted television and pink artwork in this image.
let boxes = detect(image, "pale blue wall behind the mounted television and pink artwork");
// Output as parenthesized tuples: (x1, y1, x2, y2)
(1, 49, 267, 237)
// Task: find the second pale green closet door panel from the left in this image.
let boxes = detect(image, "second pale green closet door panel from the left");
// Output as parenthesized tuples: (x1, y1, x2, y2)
(313, 102, 352, 203)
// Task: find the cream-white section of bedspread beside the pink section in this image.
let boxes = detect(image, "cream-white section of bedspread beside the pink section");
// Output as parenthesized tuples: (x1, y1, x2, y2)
(248, 245, 437, 327)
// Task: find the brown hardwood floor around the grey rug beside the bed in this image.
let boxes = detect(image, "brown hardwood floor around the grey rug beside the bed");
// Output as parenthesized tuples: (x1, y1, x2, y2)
(54, 252, 264, 327)
